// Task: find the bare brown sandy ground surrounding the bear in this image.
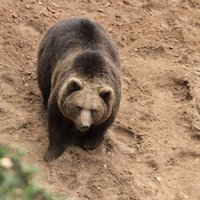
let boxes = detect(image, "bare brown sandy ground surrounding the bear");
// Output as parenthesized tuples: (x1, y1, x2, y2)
(0, 0, 200, 200)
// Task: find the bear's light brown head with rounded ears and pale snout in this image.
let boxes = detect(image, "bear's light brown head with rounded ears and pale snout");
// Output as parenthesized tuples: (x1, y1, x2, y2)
(58, 77, 115, 132)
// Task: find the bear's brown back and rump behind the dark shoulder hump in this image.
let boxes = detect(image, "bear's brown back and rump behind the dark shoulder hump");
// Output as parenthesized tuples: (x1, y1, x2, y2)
(41, 18, 119, 63)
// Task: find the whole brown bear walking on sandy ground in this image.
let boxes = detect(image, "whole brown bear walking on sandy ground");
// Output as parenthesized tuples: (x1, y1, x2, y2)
(37, 18, 121, 162)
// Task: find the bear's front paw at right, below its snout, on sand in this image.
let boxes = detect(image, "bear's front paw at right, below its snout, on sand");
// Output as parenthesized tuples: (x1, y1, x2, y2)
(82, 136, 103, 150)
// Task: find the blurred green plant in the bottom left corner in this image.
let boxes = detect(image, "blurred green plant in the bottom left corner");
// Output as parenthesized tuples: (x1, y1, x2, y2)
(0, 144, 57, 200)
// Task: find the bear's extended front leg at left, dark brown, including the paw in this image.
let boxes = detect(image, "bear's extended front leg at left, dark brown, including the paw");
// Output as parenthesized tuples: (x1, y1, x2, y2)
(44, 101, 65, 162)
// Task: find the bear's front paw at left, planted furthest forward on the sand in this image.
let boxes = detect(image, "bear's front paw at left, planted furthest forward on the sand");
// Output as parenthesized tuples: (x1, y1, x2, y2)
(44, 145, 65, 163)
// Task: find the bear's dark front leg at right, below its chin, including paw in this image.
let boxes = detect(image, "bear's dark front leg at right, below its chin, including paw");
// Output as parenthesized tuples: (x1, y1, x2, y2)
(81, 129, 106, 150)
